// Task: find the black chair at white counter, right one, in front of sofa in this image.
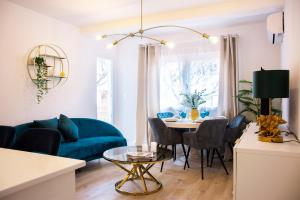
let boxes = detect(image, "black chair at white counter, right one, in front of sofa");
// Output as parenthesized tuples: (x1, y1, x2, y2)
(13, 128, 60, 155)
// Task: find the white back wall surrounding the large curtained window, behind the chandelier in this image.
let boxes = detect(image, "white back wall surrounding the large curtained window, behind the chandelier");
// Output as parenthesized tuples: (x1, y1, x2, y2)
(101, 22, 281, 144)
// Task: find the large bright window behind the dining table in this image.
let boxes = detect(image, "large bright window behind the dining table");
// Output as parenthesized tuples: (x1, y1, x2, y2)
(160, 48, 219, 116)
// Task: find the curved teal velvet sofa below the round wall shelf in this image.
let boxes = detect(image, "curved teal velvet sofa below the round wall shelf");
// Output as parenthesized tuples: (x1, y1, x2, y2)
(15, 118, 127, 161)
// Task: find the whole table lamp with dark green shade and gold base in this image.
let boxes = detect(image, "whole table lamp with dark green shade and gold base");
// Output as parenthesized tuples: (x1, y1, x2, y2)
(253, 69, 289, 142)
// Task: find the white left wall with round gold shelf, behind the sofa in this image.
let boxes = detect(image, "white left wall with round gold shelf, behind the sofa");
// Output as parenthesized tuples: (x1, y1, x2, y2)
(0, 1, 97, 125)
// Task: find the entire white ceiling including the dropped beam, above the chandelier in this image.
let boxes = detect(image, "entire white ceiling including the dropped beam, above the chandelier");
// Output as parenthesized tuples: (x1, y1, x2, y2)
(9, 0, 284, 35)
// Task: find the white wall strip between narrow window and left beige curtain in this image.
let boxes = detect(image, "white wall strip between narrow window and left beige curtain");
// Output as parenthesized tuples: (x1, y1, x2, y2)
(114, 40, 138, 145)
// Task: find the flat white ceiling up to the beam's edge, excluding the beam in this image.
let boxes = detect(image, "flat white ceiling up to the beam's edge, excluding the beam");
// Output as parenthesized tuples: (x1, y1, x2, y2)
(9, 0, 229, 26)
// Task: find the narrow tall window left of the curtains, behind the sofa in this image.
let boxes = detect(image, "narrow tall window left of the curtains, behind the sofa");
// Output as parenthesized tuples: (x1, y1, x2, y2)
(97, 58, 113, 123)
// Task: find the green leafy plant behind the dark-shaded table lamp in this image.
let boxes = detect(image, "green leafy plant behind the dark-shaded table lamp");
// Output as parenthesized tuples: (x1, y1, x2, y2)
(236, 80, 281, 118)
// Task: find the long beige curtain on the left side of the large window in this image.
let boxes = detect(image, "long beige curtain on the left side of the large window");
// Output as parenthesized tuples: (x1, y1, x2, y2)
(136, 45, 160, 145)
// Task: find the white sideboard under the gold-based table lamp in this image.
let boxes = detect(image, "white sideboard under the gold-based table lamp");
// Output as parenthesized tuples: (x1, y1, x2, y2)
(233, 123, 300, 200)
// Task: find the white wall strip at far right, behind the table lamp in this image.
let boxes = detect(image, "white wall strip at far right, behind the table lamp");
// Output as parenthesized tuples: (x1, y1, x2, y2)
(282, 0, 300, 138)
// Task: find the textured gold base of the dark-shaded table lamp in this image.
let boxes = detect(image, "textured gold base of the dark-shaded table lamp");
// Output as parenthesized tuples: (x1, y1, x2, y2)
(257, 115, 286, 143)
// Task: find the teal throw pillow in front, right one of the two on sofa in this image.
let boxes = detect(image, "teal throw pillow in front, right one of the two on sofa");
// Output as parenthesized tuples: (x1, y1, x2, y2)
(58, 114, 79, 142)
